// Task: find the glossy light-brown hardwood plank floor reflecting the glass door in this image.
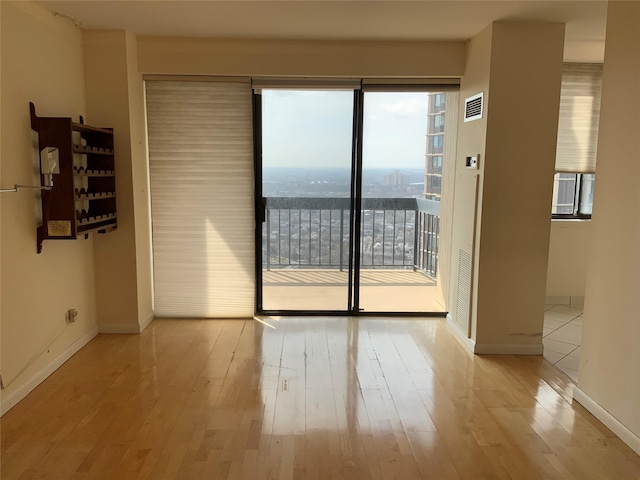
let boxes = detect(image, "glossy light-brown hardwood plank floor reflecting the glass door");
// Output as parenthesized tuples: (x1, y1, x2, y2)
(1, 317, 640, 480)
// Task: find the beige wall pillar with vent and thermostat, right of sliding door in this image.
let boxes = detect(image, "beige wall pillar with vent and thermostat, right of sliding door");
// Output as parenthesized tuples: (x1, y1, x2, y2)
(451, 21, 564, 354)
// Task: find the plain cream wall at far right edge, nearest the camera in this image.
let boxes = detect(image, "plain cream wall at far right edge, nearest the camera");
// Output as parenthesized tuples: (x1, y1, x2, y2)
(575, 1, 640, 454)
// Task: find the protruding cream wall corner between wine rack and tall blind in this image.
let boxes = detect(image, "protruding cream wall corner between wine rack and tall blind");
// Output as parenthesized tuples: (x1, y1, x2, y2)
(84, 30, 153, 333)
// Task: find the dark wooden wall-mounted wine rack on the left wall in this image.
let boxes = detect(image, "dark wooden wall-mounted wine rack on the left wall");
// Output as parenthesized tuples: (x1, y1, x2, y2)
(29, 103, 118, 253)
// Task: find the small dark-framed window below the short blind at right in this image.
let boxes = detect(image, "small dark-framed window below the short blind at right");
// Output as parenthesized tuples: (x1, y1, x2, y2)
(551, 173, 595, 219)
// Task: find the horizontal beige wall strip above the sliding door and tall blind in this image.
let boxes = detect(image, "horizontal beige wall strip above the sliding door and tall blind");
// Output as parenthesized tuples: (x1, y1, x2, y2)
(138, 37, 467, 78)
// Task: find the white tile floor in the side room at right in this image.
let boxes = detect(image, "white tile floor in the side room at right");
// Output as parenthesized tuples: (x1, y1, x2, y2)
(542, 305, 582, 382)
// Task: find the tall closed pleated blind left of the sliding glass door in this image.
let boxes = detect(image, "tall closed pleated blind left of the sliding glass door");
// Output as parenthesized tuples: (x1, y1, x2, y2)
(146, 81, 255, 317)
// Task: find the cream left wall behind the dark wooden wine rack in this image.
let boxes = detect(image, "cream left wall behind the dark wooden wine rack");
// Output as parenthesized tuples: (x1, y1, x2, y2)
(0, 1, 97, 412)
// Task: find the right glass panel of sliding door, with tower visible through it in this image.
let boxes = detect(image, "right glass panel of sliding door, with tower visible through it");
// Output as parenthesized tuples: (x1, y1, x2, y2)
(358, 92, 444, 312)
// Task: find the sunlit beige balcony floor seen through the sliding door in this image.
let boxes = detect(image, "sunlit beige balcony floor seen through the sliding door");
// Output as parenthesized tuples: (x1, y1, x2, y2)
(262, 268, 445, 313)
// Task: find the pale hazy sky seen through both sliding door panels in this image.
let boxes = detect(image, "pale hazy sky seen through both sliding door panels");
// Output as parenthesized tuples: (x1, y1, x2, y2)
(262, 90, 427, 169)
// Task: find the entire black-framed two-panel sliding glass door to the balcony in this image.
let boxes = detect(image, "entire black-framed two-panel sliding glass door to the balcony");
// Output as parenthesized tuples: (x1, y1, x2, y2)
(254, 88, 457, 313)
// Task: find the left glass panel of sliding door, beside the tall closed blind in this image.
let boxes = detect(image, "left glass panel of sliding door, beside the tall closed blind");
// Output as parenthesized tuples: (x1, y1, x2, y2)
(259, 89, 354, 311)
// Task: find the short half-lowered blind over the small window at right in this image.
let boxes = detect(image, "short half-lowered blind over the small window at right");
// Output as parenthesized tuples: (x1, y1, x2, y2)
(556, 63, 602, 173)
